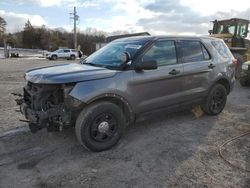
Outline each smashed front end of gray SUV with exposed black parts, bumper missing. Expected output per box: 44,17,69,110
16,82,82,132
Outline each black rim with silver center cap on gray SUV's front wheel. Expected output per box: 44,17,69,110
90,113,118,142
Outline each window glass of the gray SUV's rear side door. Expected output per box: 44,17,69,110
179,40,210,63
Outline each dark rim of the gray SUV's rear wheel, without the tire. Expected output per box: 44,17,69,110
211,90,225,112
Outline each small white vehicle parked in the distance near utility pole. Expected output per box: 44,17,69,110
46,49,78,60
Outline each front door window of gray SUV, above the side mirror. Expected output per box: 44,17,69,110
142,41,177,65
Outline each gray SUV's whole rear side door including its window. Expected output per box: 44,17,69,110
178,40,216,103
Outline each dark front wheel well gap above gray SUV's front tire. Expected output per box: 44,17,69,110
90,97,135,123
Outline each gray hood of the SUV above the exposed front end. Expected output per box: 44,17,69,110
25,63,117,84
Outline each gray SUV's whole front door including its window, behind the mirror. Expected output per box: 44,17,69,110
129,40,183,113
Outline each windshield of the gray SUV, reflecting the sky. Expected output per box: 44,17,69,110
82,40,148,68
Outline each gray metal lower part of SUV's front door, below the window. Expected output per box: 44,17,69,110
129,64,183,113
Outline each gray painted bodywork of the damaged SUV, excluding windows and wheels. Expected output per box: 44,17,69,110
26,37,234,114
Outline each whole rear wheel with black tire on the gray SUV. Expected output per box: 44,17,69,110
202,84,227,115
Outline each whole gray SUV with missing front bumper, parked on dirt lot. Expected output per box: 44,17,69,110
18,36,235,151
